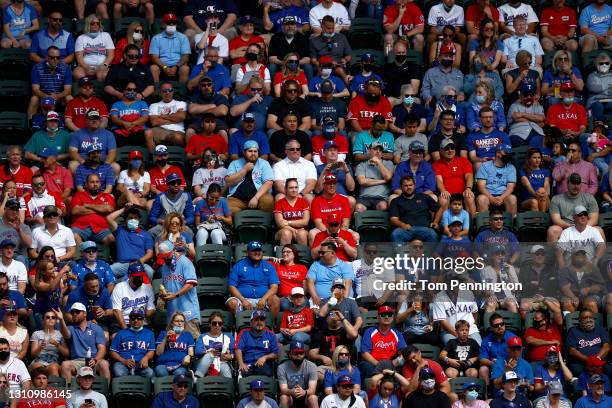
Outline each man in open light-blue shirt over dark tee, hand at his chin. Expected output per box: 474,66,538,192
225,140,274,214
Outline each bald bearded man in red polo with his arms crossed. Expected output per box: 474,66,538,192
70,173,115,245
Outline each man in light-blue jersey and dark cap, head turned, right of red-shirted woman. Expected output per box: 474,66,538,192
476,143,517,217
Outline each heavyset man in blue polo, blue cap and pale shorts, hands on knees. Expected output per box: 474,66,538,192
225,241,280,317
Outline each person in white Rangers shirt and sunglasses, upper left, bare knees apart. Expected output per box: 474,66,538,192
72,14,115,81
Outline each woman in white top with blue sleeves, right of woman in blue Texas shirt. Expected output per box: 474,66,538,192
195,310,235,378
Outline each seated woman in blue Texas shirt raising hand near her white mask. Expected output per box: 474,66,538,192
155,312,195,377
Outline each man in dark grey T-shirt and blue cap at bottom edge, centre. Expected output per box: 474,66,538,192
277,340,319,408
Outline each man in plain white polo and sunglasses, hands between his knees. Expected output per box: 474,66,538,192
273,139,317,204
